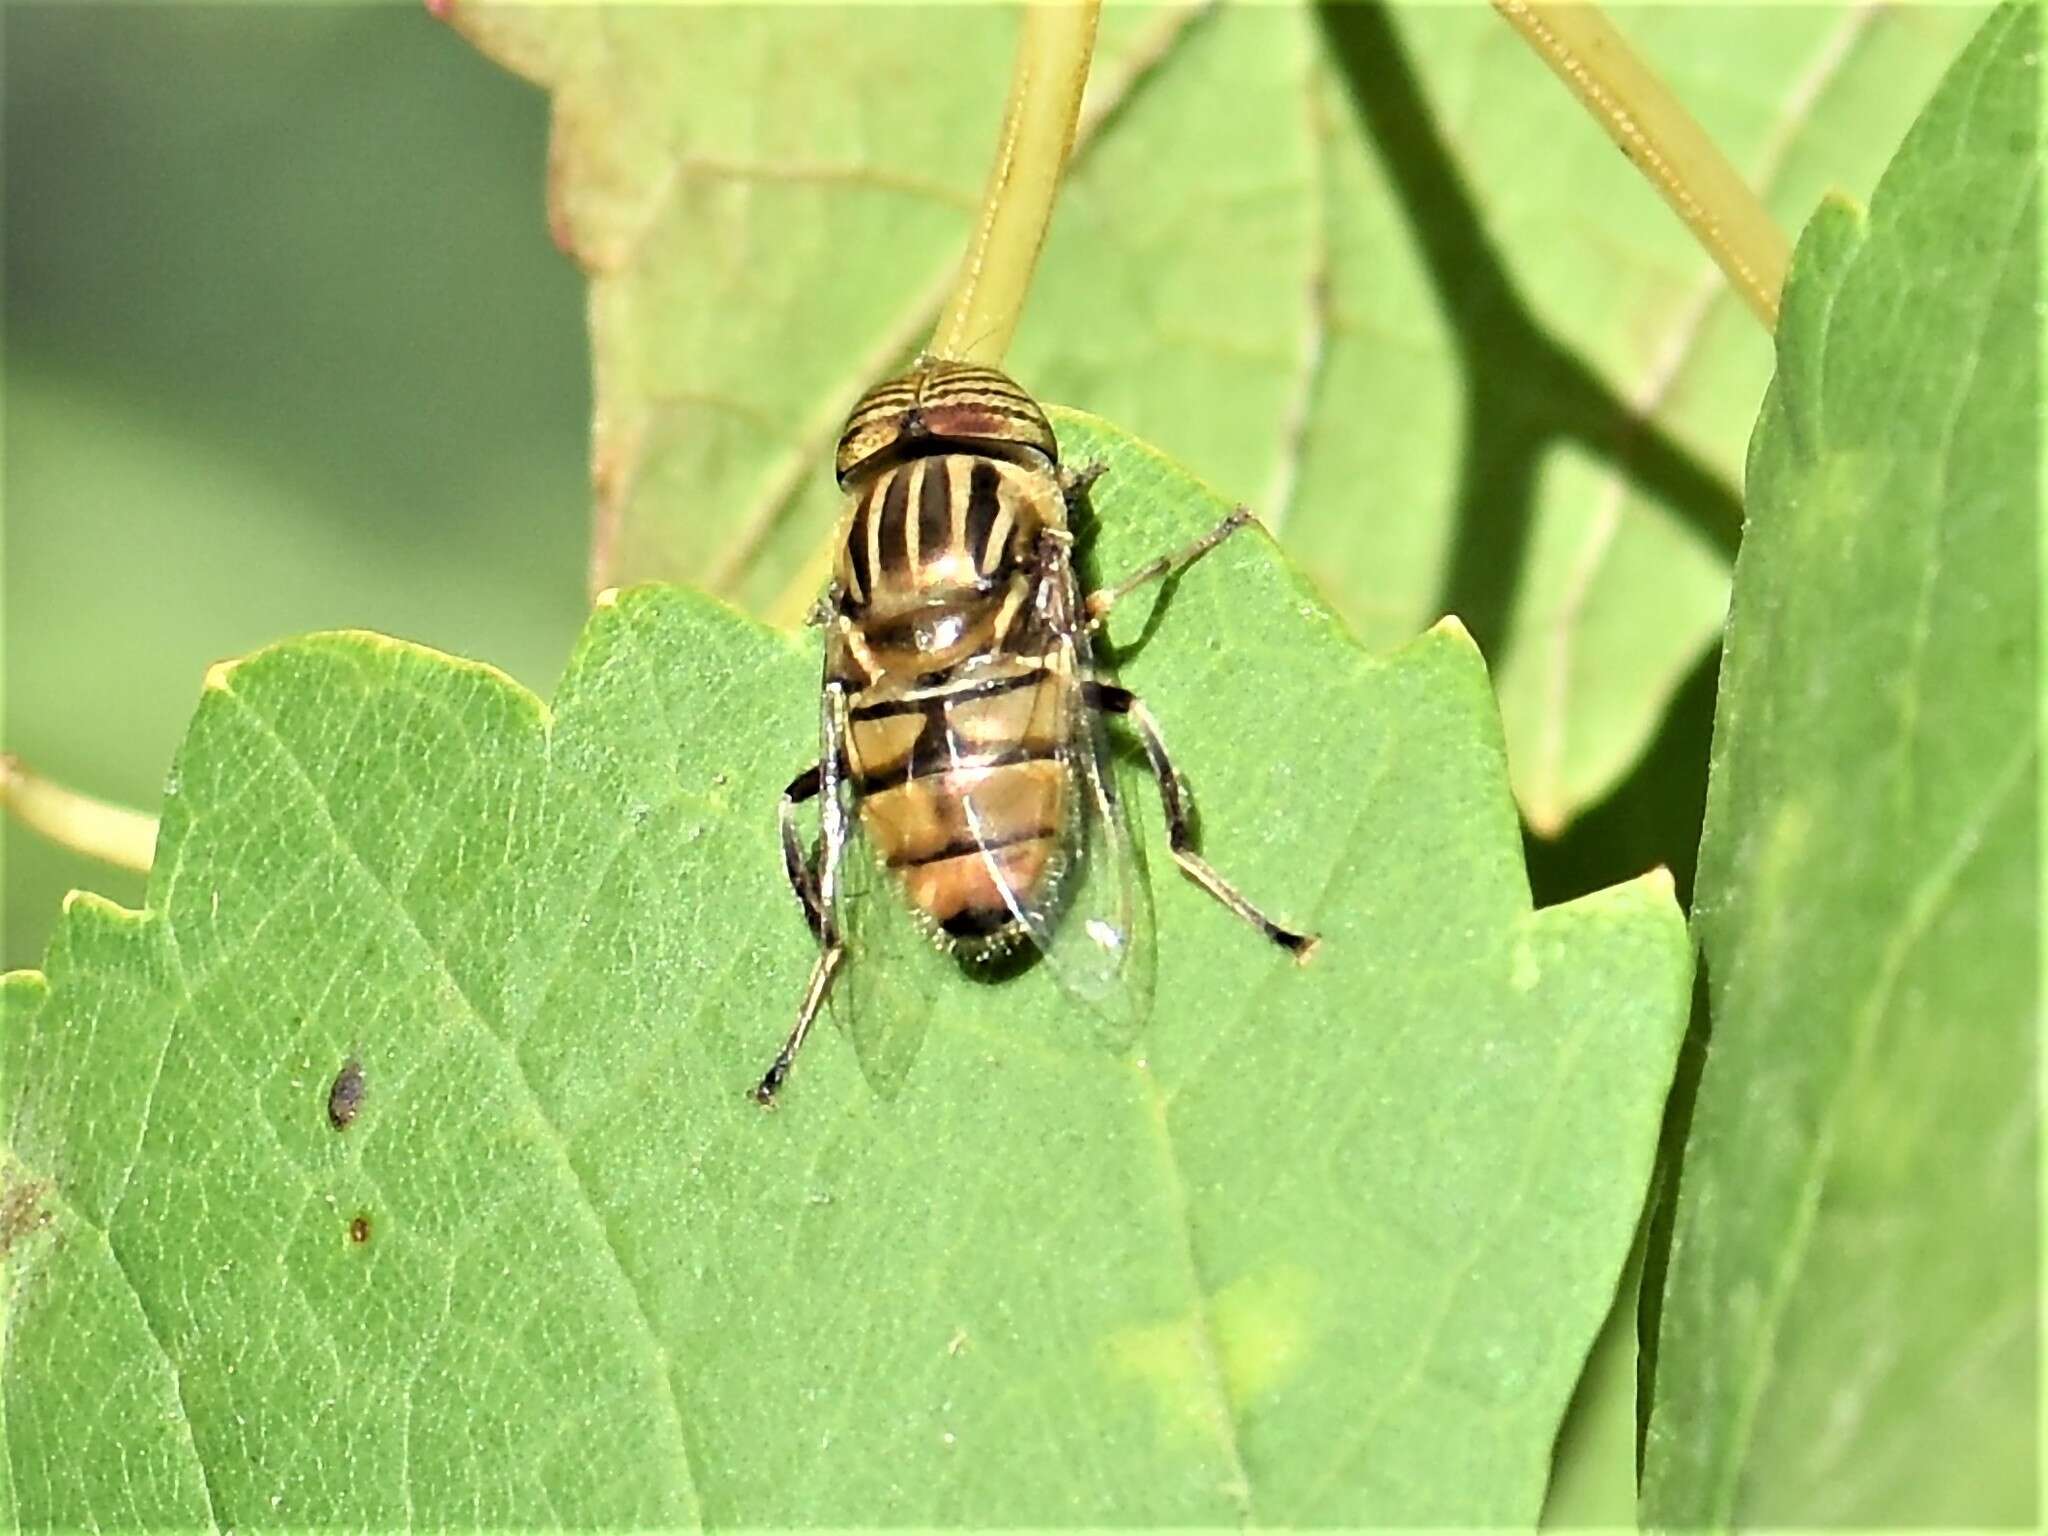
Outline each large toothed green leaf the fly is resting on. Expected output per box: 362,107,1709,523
4,414,1690,1526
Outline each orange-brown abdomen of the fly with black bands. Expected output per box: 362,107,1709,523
846,659,1071,940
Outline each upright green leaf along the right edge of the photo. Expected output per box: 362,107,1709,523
1645,4,2040,1528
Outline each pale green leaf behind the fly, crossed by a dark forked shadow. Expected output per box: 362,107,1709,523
455,0,1980,829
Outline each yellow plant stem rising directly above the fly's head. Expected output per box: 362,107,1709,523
928,0,1102,365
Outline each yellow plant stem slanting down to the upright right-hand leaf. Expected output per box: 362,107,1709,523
1493,0,1792,330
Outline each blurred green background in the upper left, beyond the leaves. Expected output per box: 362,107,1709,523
0,4,590,967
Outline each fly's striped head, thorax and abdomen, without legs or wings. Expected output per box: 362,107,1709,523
831,362,1077,948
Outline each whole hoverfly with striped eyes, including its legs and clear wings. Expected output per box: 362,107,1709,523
754,360,1315,1104
